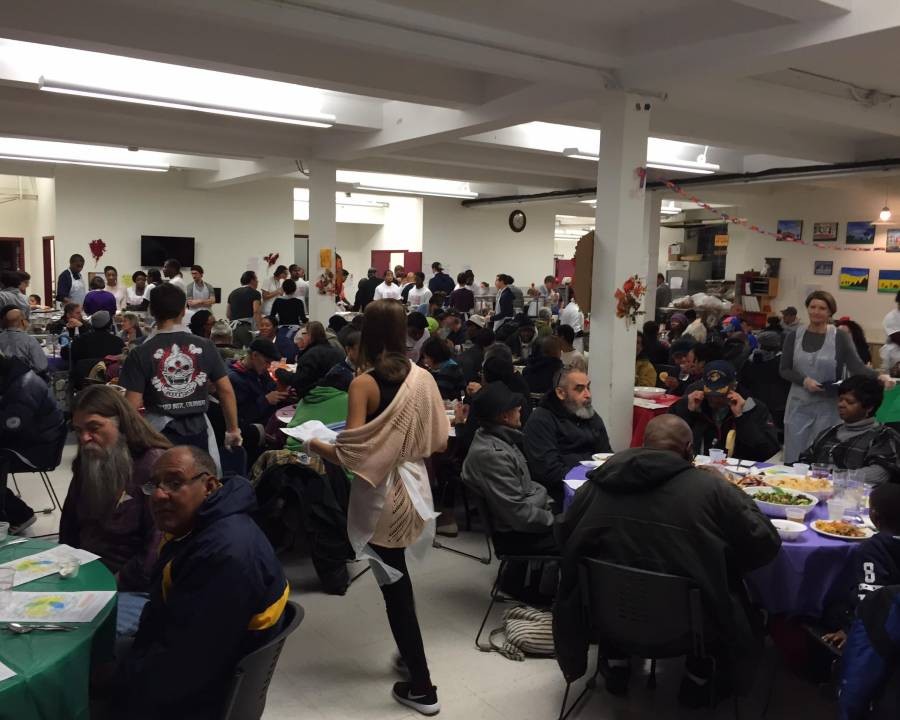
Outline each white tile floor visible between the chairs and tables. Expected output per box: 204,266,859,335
19,444,834,720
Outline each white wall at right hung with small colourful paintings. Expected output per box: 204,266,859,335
724,181,900,342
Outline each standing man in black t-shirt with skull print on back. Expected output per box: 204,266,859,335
119,283,241,466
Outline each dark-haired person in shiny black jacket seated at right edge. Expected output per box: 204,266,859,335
800,375,900,485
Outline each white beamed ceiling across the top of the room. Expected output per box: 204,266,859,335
0,0,900,193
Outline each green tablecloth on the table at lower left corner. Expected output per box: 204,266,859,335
0,540,116,720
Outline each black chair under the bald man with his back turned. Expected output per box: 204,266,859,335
559,558,716,720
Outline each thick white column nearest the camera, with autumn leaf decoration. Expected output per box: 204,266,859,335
590,93,655,451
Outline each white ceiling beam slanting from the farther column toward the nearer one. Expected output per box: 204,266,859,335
316,85,580,161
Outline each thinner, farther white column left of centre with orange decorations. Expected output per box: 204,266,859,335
306,160,337,323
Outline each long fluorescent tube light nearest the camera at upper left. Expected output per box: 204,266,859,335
38,77,336,128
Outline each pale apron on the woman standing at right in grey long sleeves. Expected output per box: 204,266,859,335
784,325,841,464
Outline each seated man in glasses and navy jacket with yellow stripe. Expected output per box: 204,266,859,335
117,446,290,720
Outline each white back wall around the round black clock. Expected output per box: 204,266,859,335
422,198,556,288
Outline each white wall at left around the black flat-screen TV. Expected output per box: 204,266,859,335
56,167,294,317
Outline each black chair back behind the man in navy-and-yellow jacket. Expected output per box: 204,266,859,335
221,601,304,720
